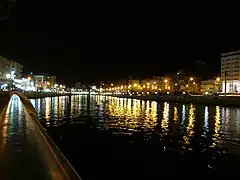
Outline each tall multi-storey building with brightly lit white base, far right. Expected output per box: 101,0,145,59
221,50,240,93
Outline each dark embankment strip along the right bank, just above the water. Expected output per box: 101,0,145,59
110,95,240,106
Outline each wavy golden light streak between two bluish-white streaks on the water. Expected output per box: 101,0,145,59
183,104,195,144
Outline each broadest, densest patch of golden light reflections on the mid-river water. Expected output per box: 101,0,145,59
105,97,157,134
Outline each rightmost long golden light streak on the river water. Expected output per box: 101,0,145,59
211,106,221,147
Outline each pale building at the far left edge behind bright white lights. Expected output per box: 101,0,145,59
0,56,23,79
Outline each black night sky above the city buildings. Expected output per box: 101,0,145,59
0,0,240,84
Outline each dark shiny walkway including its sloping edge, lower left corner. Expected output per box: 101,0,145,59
0,95,80,180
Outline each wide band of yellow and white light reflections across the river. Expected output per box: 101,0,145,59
30,95,240,152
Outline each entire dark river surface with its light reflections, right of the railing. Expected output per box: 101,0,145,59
32,96,240,180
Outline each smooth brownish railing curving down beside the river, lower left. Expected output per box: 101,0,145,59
7,92,81,180
